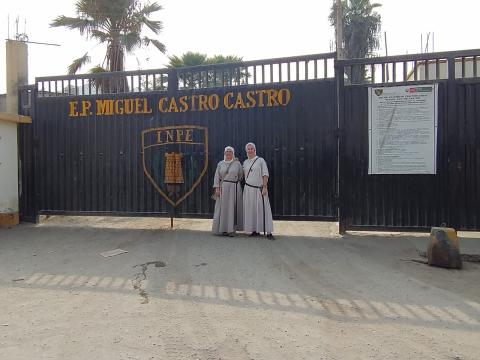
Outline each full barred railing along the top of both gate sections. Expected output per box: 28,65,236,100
36,49,480,97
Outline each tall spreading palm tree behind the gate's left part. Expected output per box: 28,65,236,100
50,0,166,74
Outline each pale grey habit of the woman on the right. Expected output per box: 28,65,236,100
243,156,273,234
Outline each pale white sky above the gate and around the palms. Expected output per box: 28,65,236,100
0,0,480,94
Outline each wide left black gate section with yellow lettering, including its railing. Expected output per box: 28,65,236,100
22,54,338,220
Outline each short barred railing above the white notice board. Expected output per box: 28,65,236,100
339,49,480,85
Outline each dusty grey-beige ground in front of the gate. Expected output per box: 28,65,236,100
0,217,480,360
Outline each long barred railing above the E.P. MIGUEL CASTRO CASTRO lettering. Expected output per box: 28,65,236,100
36,53,335,97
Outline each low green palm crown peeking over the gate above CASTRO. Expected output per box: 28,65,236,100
167,51,247,88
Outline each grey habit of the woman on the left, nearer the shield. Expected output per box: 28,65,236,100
212,159,243,234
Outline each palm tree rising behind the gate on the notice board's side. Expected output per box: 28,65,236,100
328,0,381,83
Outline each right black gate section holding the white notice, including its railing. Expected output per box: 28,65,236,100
337,50,480,231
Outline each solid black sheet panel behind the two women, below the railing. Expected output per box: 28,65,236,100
35,80,337,220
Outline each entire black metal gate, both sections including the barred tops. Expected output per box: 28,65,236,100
20,50,480,232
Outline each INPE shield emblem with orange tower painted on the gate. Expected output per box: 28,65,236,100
142,125,208,207
